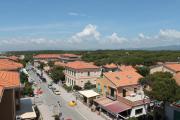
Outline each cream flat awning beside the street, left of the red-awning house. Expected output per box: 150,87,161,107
79,90,99,98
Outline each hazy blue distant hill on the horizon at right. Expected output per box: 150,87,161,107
142,45,180,50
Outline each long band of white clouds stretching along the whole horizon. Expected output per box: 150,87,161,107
0,24,180,50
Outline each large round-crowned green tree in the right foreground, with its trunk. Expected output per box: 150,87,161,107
140,72,180,120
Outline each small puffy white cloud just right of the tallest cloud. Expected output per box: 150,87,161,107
107,33,127,44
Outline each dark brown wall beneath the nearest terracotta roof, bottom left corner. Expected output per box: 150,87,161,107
0,89,15,120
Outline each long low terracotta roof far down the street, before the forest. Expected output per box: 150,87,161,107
33,54,60,59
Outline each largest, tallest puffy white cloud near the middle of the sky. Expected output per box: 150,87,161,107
69,24,100,43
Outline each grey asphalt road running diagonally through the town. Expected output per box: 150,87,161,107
29,66,86,120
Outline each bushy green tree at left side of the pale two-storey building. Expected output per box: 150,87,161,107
50,66,65,83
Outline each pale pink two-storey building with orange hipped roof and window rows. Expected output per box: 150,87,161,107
64,61,101,87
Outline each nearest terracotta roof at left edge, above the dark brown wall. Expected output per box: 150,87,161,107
0,71,20,97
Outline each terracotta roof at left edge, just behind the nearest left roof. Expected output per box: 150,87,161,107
0,59,23,70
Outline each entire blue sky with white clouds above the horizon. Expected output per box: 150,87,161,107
0,0,180,51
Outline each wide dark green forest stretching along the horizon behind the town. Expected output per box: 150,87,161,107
7,50,180,66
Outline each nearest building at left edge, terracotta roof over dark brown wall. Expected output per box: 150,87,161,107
0,71,20,120
